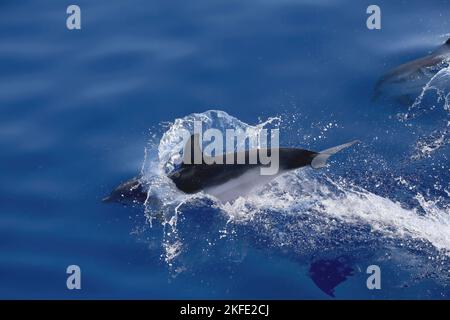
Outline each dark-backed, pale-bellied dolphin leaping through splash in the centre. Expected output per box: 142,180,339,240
103,134,358,203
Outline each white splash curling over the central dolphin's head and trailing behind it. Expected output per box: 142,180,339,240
144,111,450,264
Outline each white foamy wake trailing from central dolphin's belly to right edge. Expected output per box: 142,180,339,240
221,170,450,255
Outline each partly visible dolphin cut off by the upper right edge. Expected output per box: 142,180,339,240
373,39,450,104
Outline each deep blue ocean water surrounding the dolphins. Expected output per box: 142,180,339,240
0,0,450,299
